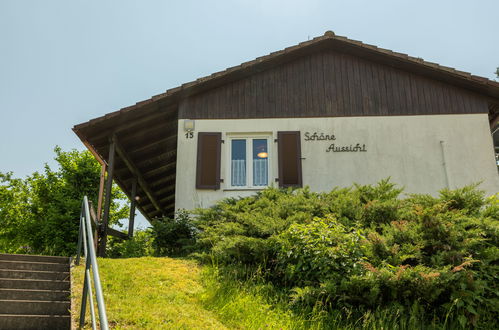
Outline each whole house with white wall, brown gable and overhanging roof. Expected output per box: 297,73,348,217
73,31,499,250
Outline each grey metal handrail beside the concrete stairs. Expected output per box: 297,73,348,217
75,196,109,330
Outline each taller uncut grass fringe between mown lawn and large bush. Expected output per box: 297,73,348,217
201,263,462,330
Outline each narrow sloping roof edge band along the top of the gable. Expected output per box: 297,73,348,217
74,31,499,133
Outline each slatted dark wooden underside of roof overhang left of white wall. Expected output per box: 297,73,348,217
73,101,178,220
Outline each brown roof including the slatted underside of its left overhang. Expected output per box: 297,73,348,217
73,31,499,220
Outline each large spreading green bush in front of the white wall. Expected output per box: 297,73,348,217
191,180,499,327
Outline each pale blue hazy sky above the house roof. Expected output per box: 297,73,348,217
0,0,499,227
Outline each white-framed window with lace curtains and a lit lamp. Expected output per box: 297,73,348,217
229,136,269,188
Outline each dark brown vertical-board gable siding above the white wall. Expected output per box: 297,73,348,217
179,51,488,119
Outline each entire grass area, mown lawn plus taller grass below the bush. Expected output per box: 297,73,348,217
71,257,458,330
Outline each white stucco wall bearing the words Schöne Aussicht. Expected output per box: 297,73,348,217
175,114,499,209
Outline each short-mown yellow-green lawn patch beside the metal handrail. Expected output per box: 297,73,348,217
72,257,226,329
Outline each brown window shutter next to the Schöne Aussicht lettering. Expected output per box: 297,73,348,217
277,131,303,187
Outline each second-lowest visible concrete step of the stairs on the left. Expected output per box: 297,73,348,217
0,300,71,315
